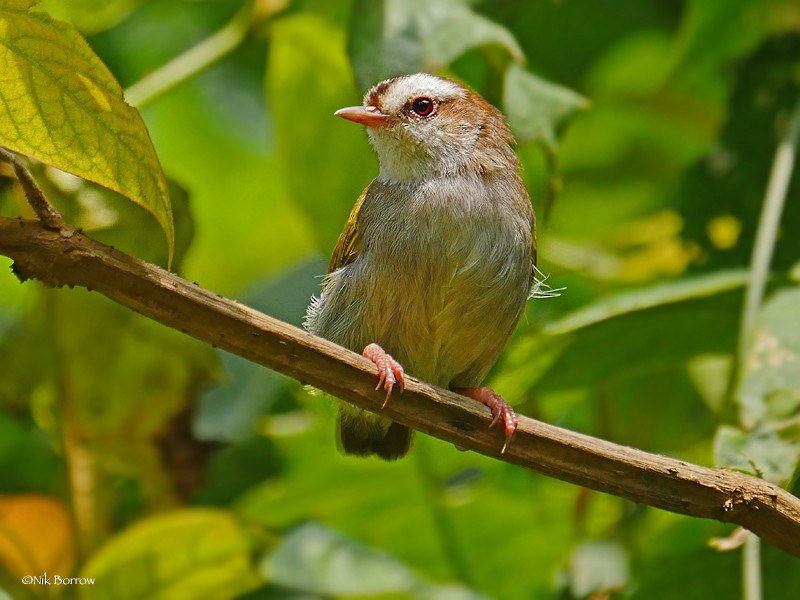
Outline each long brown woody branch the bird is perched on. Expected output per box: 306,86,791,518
0,218,800,556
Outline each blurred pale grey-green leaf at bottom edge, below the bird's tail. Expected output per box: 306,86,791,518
261,523,420,596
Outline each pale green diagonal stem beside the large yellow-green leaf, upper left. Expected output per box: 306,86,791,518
125,0,254,107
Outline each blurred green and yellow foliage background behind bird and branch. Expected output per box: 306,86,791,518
0,0,800,600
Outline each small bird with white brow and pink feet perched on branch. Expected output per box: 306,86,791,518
306,73,536,460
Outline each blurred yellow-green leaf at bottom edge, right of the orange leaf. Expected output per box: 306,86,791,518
81,509,259,600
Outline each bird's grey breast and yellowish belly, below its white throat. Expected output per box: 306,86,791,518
350,176,531,385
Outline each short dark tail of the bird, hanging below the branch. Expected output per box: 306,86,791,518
336,409,414,460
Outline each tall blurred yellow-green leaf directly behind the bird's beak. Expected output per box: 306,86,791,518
266,14,378,253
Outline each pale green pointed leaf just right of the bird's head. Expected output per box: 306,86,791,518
503,63,589,151
